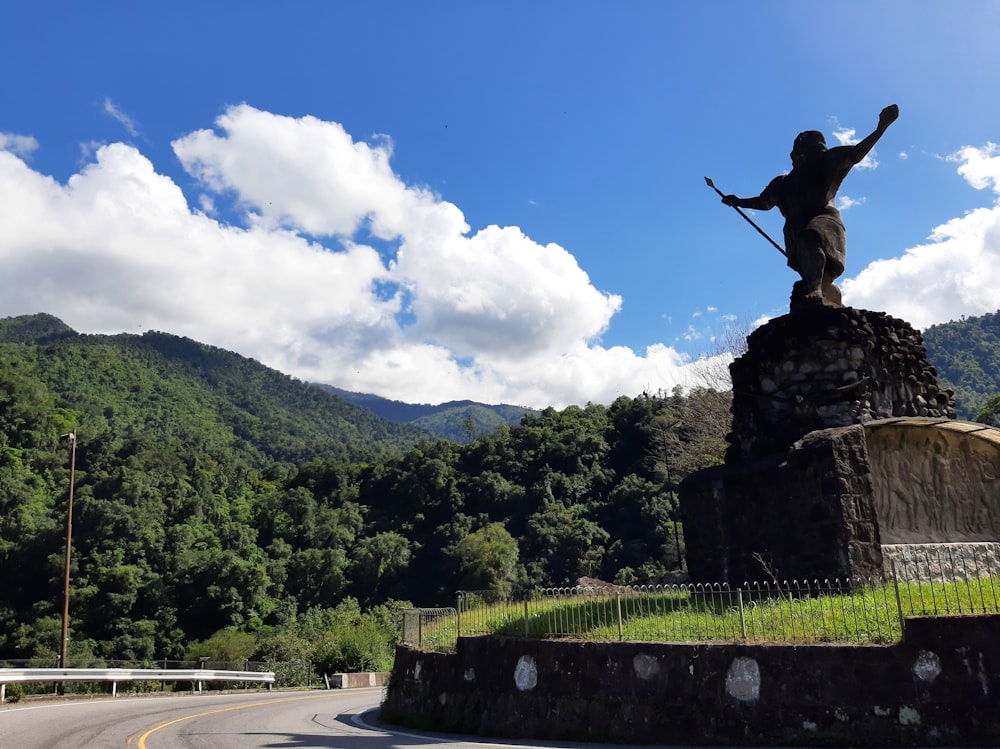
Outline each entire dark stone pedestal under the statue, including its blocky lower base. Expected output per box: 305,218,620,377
680,306,954,585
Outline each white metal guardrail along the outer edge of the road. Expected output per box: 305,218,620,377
0,668,274,703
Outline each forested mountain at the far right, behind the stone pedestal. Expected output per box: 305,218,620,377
923,312,1000,420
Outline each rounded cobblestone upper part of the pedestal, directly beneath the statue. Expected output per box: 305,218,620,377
726,305,955,463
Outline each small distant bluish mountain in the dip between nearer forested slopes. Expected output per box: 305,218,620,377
318,385,538,442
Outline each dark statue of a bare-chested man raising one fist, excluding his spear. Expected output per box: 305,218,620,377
722,104,899,307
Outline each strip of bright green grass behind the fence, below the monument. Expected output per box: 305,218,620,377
408,577,1000,650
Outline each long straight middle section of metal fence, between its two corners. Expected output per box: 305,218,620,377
456,580,902,642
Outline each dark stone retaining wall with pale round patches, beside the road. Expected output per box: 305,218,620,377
382,616,1000,746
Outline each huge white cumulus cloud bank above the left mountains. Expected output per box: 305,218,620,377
0,102,686,406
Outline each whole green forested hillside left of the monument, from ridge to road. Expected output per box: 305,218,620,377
0,316,728,660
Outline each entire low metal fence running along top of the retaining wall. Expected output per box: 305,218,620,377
403,545,1000,649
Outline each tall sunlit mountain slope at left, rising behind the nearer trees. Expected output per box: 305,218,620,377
0,315,428,463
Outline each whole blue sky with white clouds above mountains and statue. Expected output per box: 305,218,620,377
0,0,1000,407
